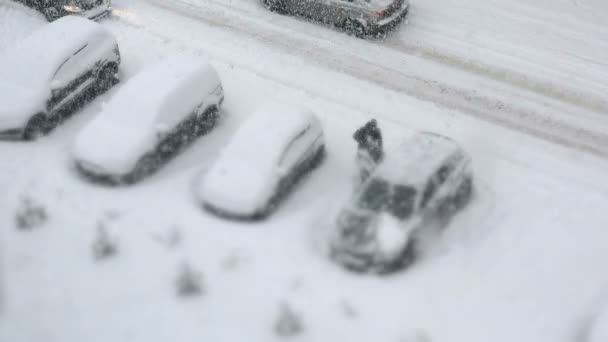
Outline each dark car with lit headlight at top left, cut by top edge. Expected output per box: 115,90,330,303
17,0,112,21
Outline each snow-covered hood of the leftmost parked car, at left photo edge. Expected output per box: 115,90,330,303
0,81,45,130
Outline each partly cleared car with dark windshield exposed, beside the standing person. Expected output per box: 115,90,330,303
330,133,473,273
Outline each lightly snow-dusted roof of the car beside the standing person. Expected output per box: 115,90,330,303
374,132,463,187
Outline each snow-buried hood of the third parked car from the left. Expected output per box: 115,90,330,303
198,156,279,216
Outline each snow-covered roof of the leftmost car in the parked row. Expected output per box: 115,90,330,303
0,16,116,87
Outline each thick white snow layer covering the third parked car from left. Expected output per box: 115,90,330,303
198,103,323,215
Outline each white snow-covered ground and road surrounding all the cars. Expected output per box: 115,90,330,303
0,0,608,342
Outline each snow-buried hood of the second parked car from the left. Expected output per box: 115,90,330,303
73,115,155,176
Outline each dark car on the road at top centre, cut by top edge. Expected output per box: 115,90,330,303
262,0,410,37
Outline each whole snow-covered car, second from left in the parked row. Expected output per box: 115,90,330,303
73,56,224,184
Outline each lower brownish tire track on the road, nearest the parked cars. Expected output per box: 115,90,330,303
142,0,608,158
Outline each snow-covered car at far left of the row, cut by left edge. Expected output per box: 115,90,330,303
0,17,120,140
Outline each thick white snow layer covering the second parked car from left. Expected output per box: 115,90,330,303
73,55,221,175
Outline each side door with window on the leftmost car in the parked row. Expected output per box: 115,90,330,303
47,43,95,112
